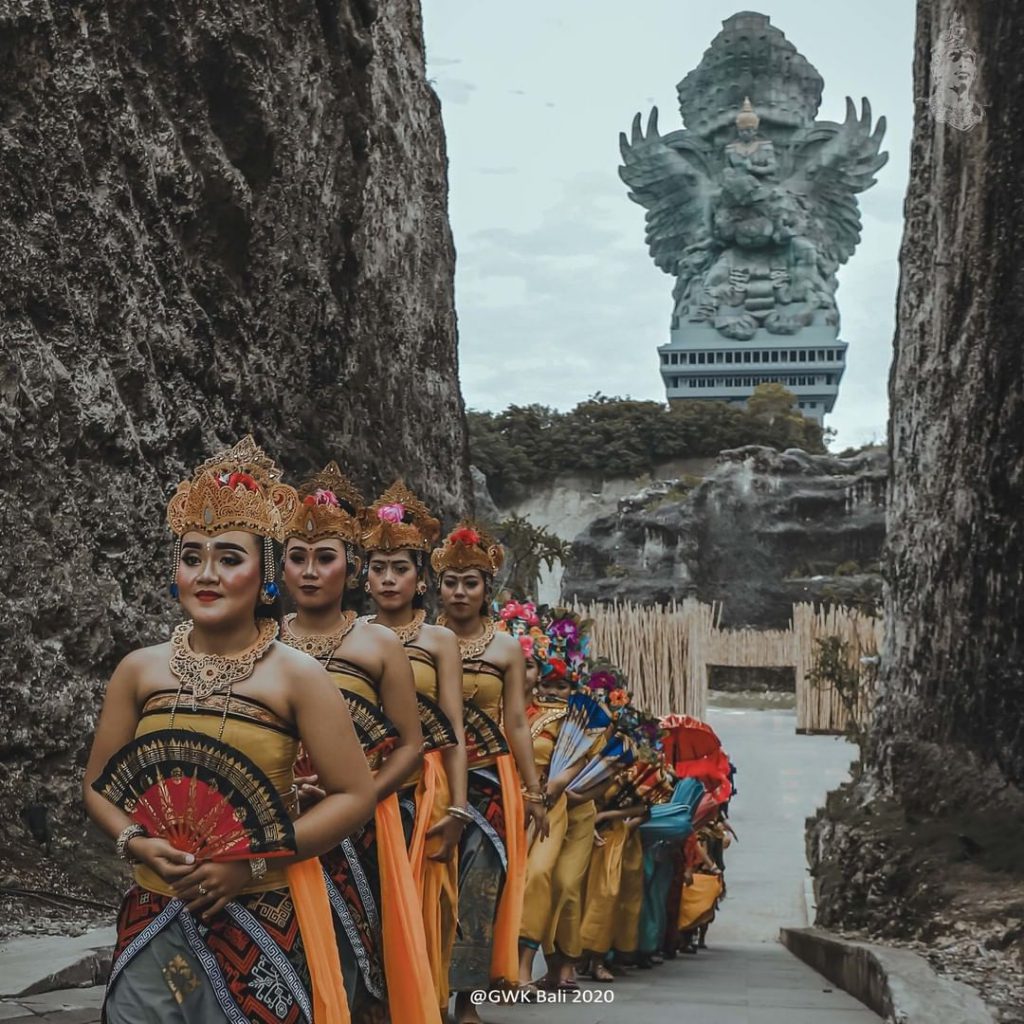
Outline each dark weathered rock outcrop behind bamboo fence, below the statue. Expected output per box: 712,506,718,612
562,446,887,628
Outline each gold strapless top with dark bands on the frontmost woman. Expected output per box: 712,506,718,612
135,690,299,896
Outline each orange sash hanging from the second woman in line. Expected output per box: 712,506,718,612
376,793,440,1024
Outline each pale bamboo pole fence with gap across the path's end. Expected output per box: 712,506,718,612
577,598,882,733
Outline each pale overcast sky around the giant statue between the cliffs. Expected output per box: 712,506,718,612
423,0,914,449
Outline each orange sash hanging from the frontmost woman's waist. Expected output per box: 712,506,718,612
285,857,351,1024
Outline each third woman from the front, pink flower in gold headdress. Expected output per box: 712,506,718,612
362,481,471,1010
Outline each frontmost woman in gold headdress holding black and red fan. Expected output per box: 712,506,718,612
84,437,374,1024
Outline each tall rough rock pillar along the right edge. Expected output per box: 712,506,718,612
811,0,1024,1007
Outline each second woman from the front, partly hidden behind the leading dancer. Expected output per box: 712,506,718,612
283,463,438,1024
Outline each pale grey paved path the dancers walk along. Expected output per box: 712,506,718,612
0,709,880,1024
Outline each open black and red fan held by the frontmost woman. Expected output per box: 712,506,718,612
92,729,295,861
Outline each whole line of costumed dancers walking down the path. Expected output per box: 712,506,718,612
83,437,733,1024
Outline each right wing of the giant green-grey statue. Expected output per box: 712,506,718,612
785,96,889,264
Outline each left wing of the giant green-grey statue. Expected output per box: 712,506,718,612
618,106,714,274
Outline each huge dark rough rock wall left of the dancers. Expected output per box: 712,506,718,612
0,0,472,888
